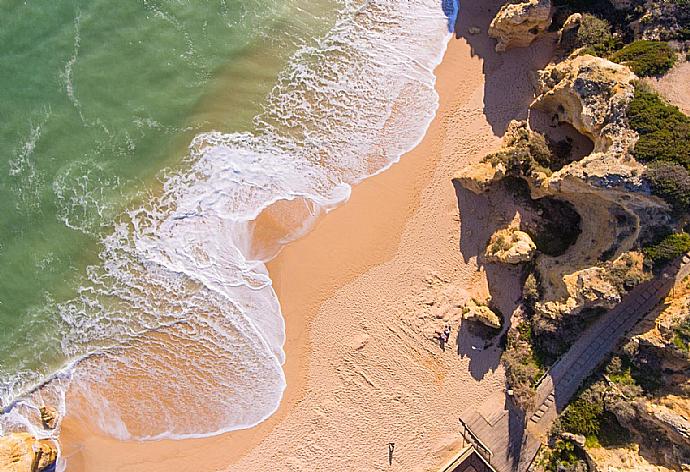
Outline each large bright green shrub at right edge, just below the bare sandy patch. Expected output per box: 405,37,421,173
628,83,690,170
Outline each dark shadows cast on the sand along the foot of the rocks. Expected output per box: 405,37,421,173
446,0,555,464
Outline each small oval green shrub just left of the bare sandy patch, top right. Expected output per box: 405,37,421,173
609,39,676,77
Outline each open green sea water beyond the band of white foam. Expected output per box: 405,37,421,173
0,0,334,399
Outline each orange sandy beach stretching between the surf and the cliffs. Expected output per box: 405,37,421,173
62,0,549,472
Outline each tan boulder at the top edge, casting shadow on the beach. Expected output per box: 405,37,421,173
489,0,552,52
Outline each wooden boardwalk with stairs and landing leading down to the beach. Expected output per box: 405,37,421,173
460,256,690,472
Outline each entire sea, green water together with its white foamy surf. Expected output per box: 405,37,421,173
0,0,454,439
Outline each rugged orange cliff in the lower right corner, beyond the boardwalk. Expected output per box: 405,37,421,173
576,281,690,471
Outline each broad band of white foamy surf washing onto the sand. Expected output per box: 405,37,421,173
0,0,448,439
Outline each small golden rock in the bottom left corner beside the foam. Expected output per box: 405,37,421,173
0,433,58,472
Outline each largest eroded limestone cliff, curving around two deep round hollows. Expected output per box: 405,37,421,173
456,55,670,328
